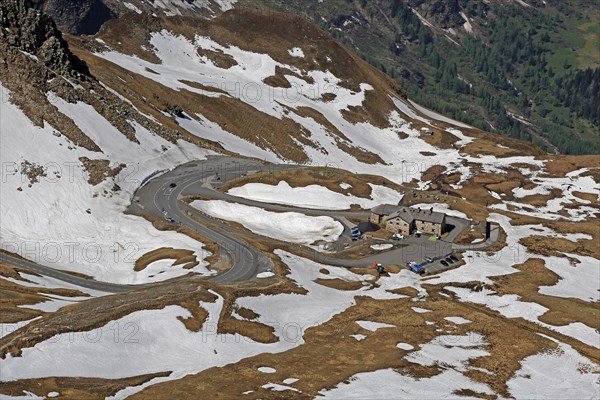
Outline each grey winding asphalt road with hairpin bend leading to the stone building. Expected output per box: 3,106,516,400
0,156,495,293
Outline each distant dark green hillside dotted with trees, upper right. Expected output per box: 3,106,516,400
241,0,600,154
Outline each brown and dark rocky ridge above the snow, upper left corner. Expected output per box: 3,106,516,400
0,0,190,152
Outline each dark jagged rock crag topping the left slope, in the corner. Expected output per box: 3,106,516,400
0,0,89,79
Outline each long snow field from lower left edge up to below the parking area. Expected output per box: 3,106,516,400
0,251,404,398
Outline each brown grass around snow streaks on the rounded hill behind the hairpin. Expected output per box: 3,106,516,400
68,9,412,163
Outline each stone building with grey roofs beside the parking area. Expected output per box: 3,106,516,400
370,204,446,236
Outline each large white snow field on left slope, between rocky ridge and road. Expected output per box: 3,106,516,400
0,87,216,283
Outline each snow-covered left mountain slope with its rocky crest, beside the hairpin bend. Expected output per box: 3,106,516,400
0,1,216,282
